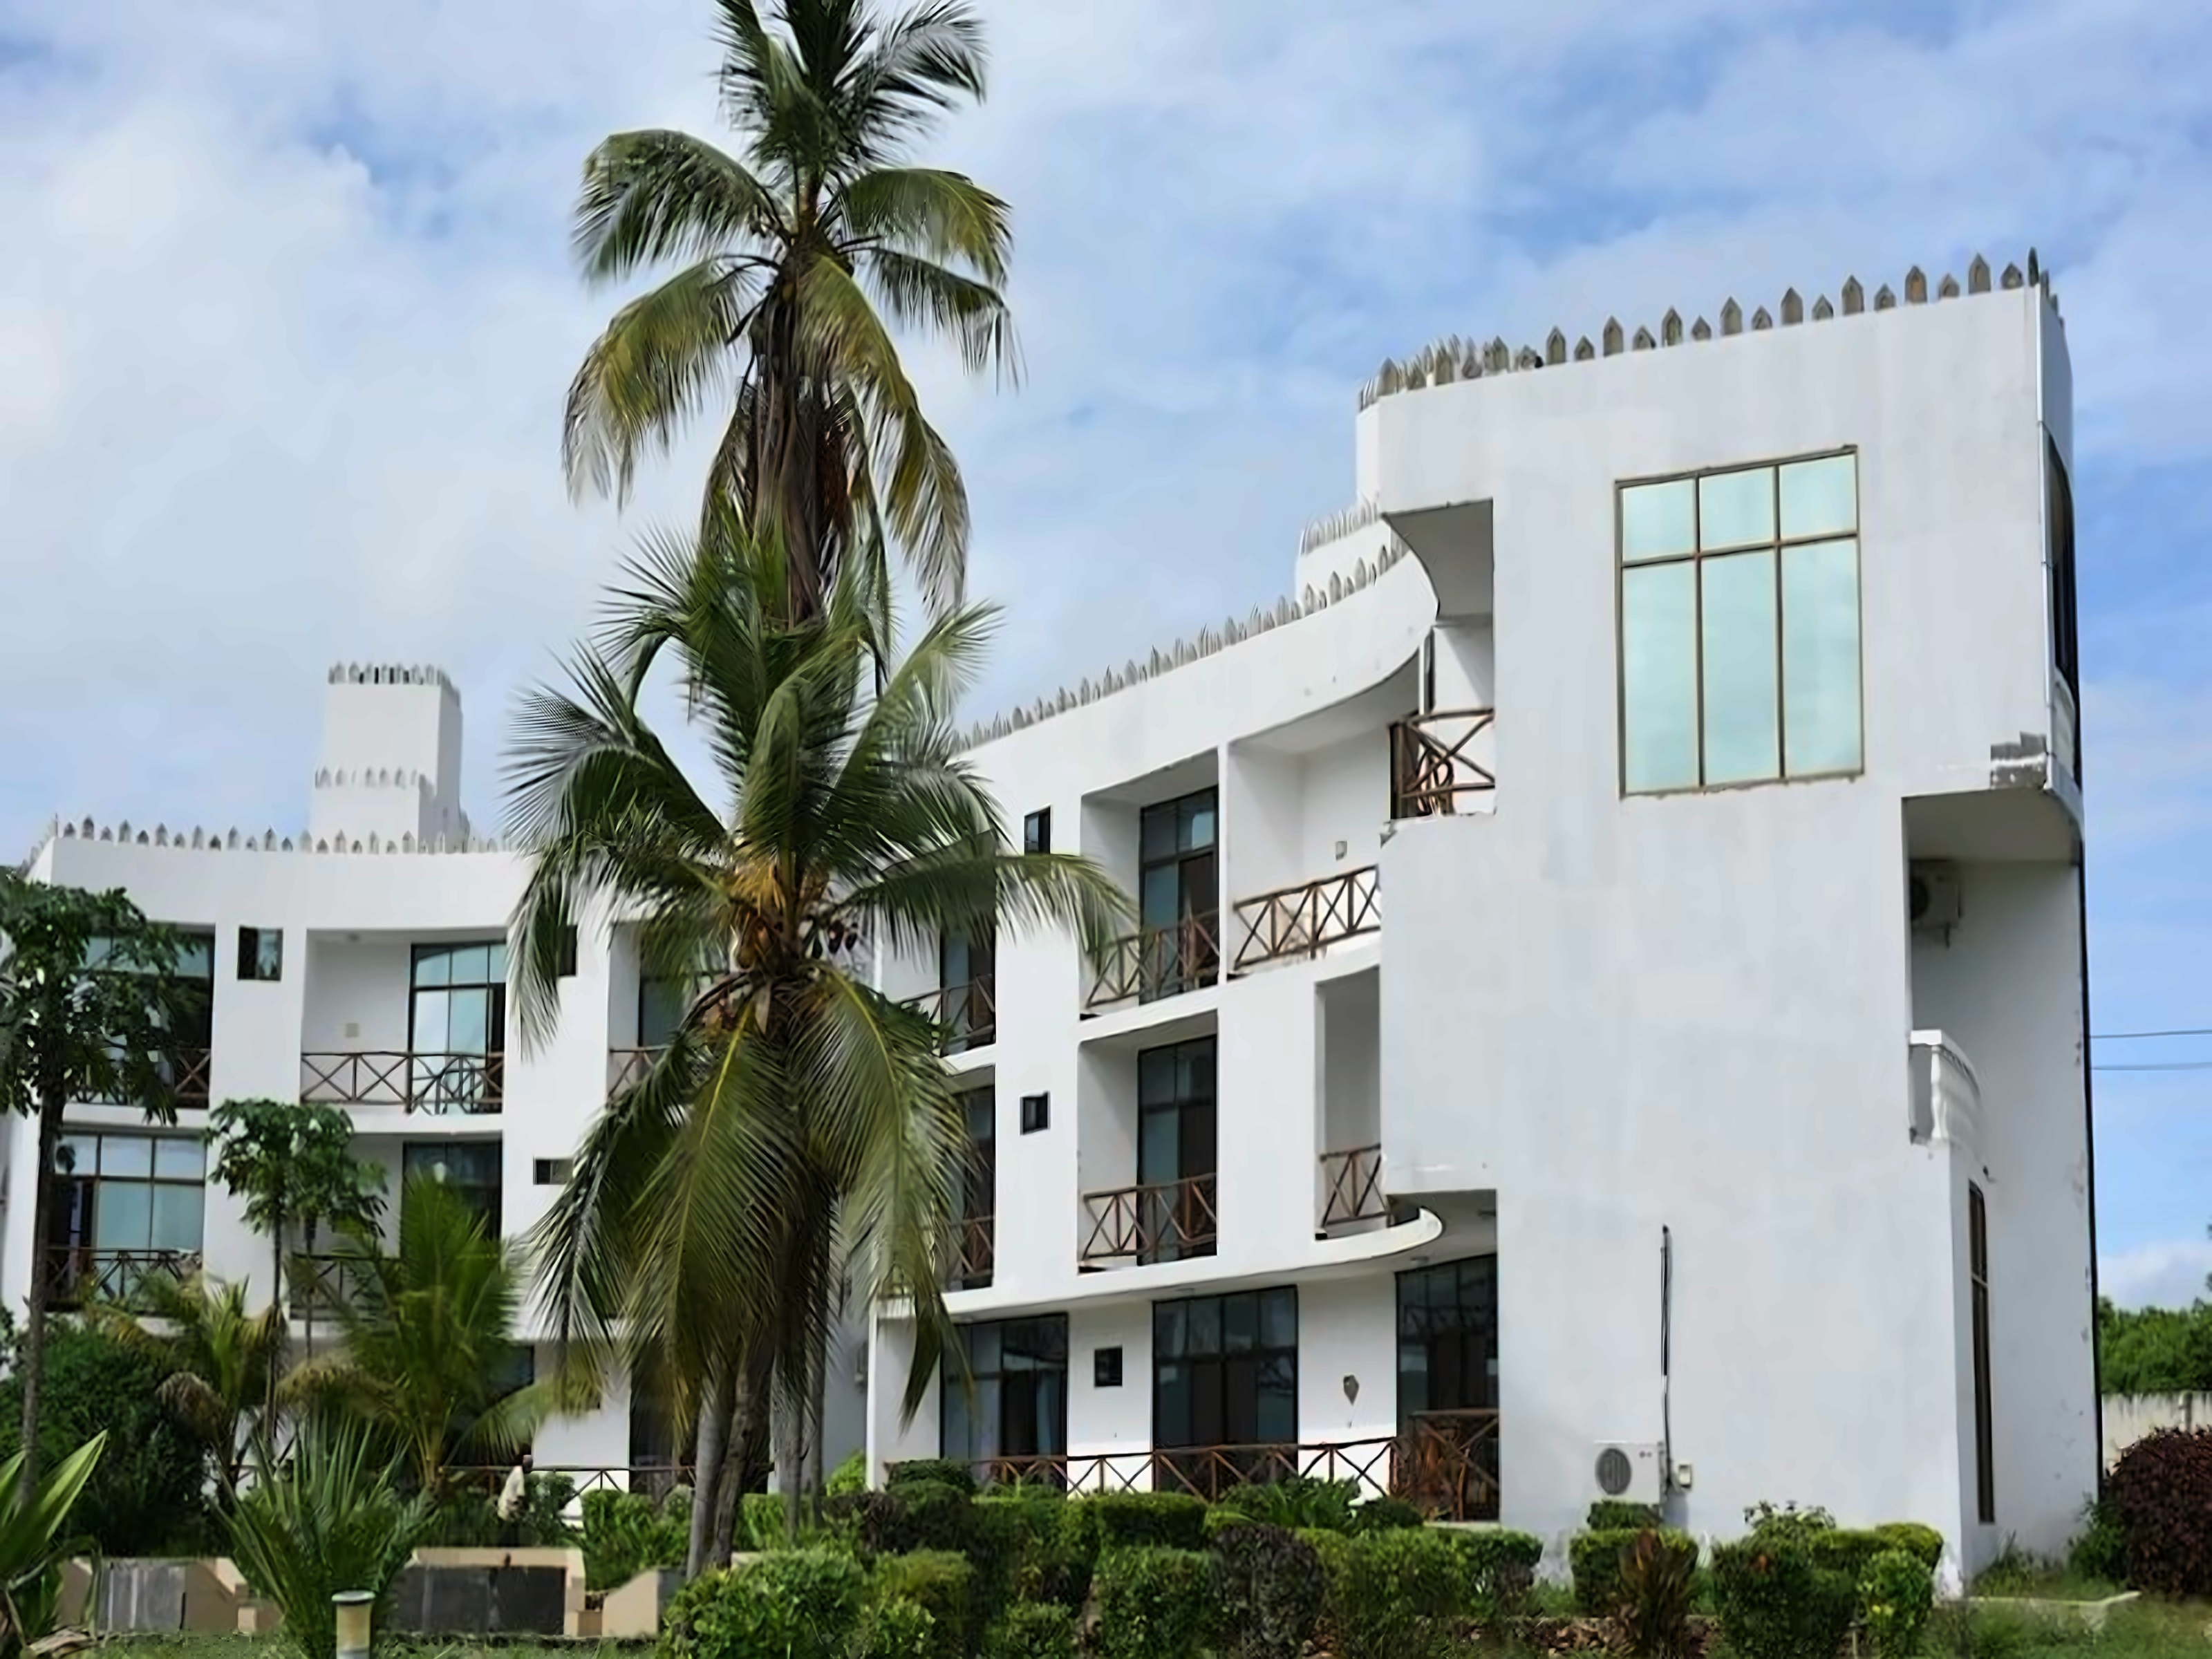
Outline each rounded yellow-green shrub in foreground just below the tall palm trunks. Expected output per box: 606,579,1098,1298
659,1548,867,1659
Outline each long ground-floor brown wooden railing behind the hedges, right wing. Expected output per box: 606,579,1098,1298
898,1412,1497,1519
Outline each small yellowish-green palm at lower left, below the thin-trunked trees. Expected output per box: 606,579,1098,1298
84,1274,285,1493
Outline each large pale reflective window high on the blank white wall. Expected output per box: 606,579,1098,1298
1619,453,1865,794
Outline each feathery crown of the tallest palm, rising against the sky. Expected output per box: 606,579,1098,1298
562,0,1018,626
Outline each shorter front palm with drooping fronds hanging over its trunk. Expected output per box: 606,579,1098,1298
511,520,1128,1566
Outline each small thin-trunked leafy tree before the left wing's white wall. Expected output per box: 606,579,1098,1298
208,1099,385,1353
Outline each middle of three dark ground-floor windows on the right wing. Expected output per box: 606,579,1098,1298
1152,1285,1298,1449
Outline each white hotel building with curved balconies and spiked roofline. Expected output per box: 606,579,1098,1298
4,259,2097,1568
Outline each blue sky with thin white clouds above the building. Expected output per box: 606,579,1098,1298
0,0,2212,1301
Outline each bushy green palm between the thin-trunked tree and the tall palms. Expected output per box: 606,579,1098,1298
283,1179,577,1495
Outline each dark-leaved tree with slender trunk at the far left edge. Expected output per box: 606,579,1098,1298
0,870,206,1502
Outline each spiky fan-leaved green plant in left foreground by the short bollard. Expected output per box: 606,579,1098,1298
230,1420,433,1659
